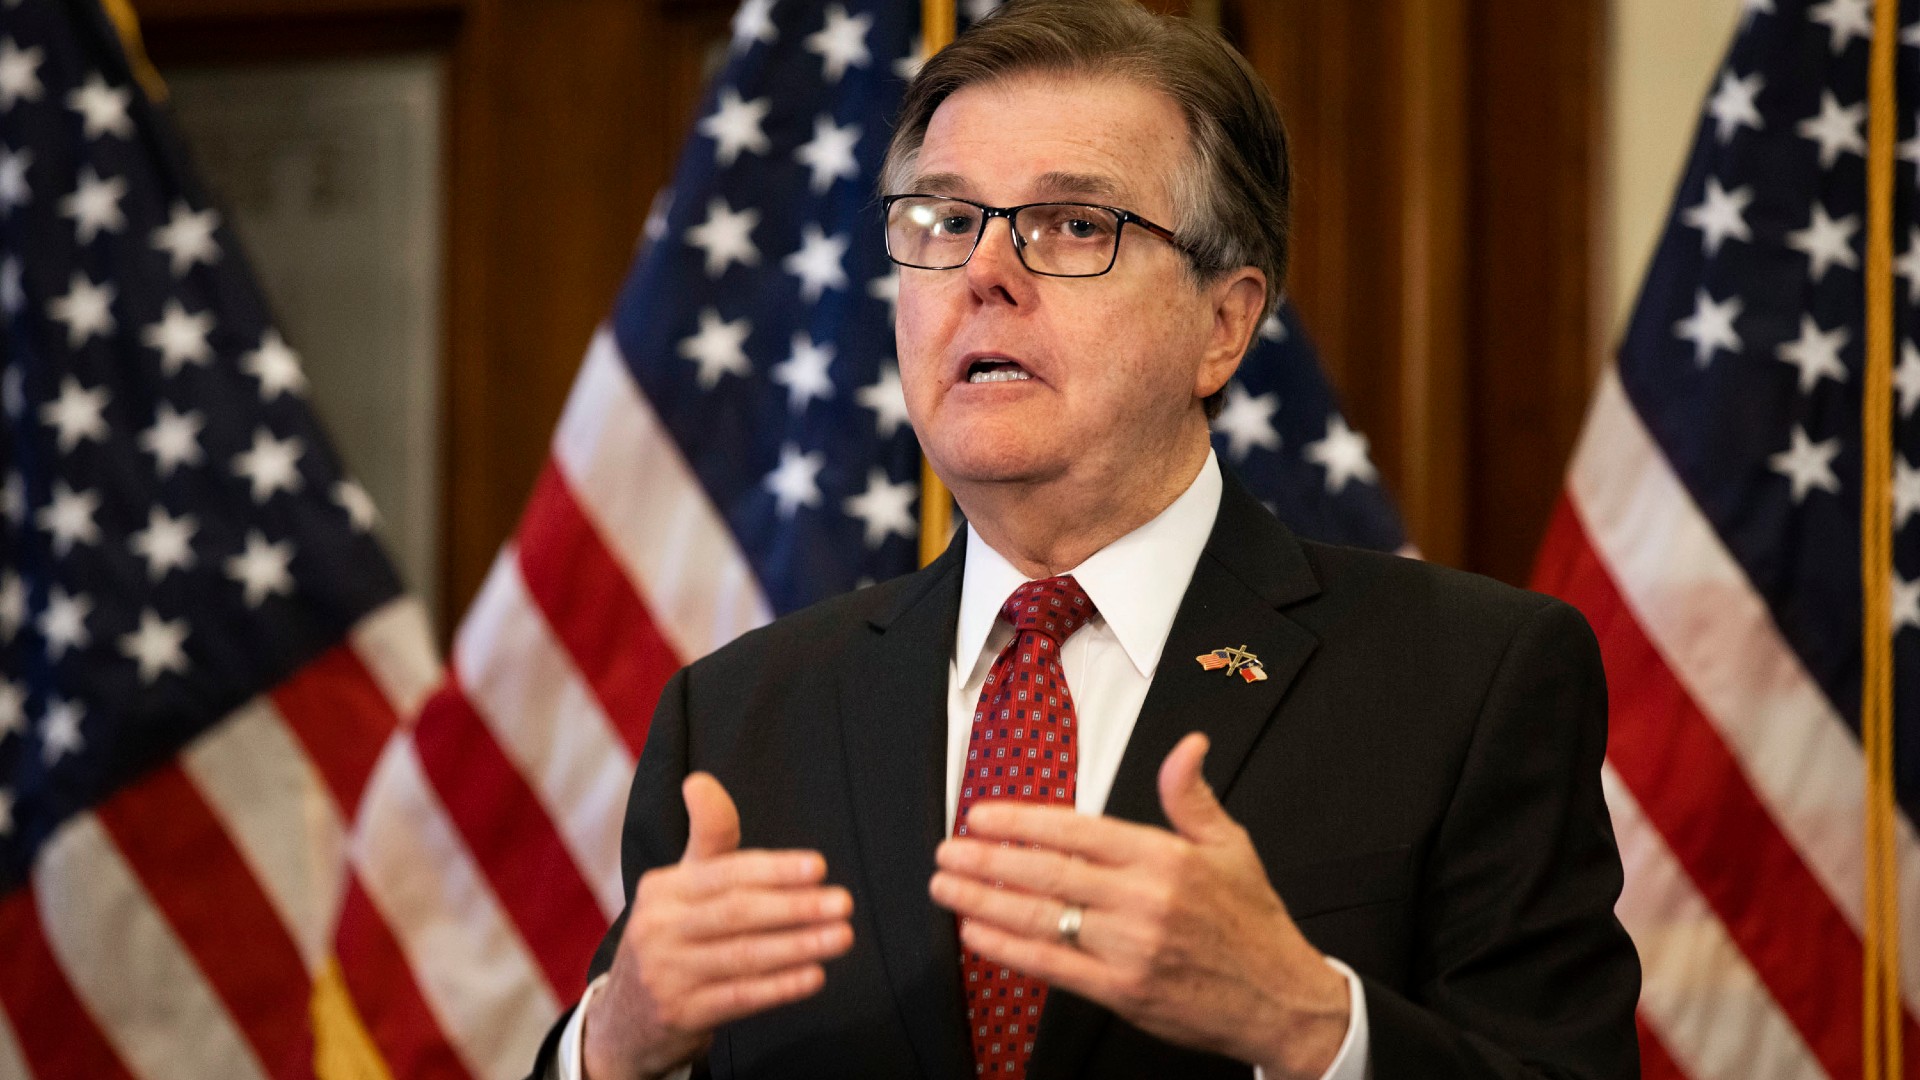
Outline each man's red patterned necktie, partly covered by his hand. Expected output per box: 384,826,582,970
954,577,1094,1080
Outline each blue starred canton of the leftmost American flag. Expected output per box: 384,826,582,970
0,0,399,892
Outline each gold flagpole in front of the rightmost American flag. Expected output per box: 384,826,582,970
1860,0,1905,1080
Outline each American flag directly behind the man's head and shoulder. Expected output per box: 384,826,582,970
322,0,1404,1080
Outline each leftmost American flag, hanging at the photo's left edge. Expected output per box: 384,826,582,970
0,0,438,1078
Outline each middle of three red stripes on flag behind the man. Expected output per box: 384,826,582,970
413,675,607,1001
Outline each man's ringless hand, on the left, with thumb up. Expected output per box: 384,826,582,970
584,773,852,1080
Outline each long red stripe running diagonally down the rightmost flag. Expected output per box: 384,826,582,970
1534,500,1920,1076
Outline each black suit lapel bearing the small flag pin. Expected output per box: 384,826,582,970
1027,467,1317,1080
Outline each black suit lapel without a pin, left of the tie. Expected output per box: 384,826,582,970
839,530,973,1078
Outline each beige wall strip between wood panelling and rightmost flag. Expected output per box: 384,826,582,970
1601,0,1741,336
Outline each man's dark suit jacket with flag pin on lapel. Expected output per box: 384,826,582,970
541,466,1640,1080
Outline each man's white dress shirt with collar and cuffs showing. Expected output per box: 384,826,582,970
557,452,1371,1080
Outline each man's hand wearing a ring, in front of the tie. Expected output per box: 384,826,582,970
929,732,1350,1080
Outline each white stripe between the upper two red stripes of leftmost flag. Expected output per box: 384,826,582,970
180,698,346,972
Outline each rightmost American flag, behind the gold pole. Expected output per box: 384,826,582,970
1536,0,1920,1080
